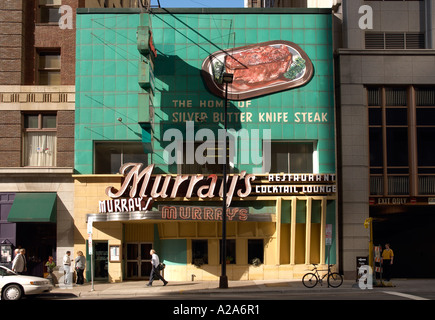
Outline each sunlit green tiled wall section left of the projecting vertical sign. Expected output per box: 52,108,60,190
75,14,141,173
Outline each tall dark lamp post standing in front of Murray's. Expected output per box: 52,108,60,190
219,72,233,289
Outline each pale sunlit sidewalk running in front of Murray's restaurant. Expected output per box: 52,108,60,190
51,279,428,299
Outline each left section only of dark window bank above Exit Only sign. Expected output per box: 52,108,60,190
367,87,409,195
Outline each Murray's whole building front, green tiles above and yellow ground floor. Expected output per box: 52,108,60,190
75,9,338,281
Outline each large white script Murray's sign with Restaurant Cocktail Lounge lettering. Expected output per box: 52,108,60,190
99,163,337,213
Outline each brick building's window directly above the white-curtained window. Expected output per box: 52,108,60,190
37,50,61,85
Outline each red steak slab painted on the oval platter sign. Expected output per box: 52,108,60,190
225,45,292,84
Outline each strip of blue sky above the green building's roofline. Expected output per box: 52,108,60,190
151,0,244,8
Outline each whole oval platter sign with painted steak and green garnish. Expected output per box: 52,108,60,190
201,40,314,100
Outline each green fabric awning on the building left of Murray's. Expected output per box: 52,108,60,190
8,192,57,223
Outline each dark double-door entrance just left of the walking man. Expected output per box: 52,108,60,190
126,242,153,280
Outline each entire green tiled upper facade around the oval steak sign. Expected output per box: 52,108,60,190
75,9,335,174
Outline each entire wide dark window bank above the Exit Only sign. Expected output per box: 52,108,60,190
367,86,435,196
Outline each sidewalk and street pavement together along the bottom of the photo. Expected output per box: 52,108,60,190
46,279,435,300
